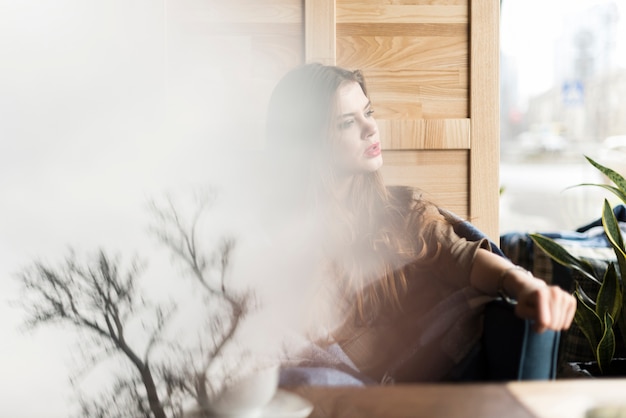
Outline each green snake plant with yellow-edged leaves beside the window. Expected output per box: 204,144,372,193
530,157,626,375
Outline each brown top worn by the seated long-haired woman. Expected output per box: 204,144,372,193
332,202,493,382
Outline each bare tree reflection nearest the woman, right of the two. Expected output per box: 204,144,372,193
151,196,252,406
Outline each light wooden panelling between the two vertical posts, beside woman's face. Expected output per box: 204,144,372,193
336,0,471,229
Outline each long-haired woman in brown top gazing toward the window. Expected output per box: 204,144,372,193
260,64,576,381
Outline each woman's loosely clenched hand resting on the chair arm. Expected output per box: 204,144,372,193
515,279,576,332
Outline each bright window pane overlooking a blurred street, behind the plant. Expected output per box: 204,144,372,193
500,0,626,233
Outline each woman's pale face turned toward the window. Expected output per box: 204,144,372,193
333,82,383,176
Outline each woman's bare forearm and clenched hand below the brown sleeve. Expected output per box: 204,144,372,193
470,248,576,332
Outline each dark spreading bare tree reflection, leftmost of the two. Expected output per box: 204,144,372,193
19,251,172,418
